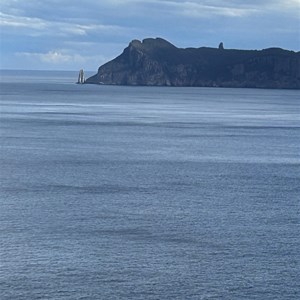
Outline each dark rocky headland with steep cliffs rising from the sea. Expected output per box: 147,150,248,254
86,38,300,89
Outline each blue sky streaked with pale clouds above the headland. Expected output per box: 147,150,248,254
0,0,300,71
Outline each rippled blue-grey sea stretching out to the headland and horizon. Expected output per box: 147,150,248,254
0,71,300,300
